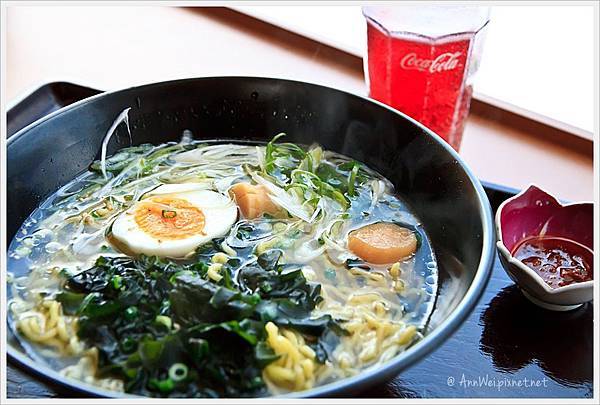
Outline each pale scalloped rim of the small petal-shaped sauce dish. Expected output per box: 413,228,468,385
495,183,594,299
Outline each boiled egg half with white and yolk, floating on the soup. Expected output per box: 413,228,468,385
111,183,237,258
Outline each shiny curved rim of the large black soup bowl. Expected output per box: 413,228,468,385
6,75,495,398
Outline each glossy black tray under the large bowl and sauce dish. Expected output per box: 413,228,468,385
6,82,593,398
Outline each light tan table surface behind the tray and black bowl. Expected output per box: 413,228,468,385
6,6,593,200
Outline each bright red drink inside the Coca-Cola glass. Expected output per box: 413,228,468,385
365,7,487,150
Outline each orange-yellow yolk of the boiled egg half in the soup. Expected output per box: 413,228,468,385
134,197,205,240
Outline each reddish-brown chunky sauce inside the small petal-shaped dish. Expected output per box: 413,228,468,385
512,237,594,288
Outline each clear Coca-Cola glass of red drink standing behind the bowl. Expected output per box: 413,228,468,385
363,5,489,150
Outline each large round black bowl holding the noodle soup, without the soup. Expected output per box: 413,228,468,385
6,77,494,396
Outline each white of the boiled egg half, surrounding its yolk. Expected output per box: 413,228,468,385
112,183,237,258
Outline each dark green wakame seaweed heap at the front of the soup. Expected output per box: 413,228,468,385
57,245,345,397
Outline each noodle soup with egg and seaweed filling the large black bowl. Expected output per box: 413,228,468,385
9,136,438,397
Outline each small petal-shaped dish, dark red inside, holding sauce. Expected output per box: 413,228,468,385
496,185,595,311
